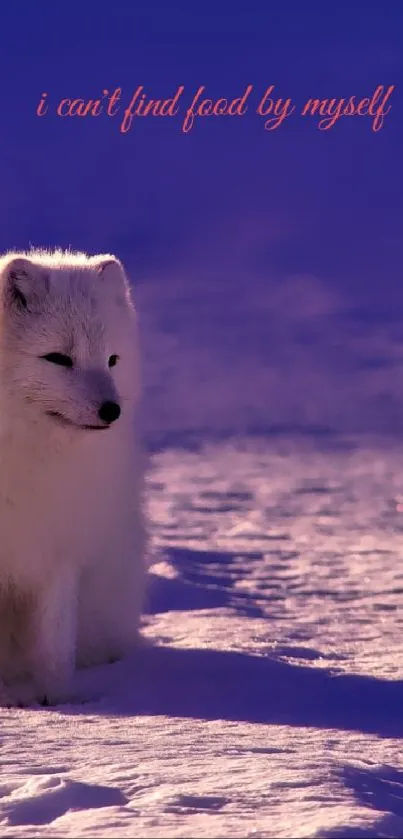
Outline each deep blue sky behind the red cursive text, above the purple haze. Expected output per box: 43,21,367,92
0,0,403,308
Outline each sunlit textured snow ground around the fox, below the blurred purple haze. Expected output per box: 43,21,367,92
0,434,403,837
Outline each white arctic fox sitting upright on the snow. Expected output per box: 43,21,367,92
0,250,146,705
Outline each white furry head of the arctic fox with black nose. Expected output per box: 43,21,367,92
0,251,139,434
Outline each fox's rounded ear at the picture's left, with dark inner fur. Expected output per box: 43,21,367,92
3,257,49,311
